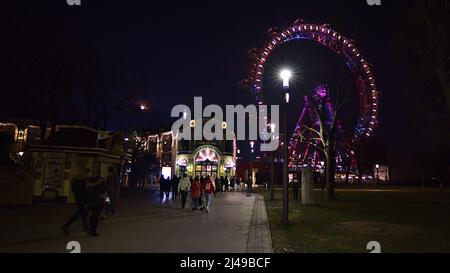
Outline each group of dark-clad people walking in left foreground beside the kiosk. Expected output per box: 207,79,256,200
61,167,120,237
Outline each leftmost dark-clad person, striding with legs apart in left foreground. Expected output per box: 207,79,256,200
61,169,91,235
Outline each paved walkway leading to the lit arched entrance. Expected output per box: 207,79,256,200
0,192,272,253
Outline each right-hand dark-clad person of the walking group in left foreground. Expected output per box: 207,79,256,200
86,171,107,237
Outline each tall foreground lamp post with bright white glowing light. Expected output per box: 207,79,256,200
280,70,292,225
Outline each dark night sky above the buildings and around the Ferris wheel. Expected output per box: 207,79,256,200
0,0,442,160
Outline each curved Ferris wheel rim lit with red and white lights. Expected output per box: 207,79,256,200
248,20,380,142
